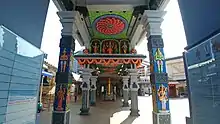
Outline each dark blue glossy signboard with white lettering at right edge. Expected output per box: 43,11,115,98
186,34,220,124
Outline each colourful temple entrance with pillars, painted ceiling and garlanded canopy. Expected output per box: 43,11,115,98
53,1,170,124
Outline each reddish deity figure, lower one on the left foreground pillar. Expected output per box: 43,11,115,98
57,85,66,111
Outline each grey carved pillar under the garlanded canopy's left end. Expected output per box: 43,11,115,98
80,68,91,115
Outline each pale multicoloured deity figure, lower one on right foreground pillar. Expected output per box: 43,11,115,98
157,84,168,111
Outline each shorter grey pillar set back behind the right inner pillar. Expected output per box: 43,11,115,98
122,76,129,107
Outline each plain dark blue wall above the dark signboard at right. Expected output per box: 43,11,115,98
178,0,220,45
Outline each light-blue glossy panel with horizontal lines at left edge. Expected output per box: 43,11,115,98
0,27,44,124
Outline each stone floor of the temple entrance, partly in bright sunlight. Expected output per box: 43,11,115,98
40,96,189,124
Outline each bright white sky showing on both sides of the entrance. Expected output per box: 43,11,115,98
41,0,186,67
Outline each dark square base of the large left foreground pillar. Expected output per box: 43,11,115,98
51,110,70,124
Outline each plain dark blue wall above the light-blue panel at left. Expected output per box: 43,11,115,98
0,0,49,48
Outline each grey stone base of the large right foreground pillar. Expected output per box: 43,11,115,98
152,112,171,124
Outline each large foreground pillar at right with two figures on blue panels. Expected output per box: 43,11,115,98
144,10,171,124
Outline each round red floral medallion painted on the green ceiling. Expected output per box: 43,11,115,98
96,17,125,35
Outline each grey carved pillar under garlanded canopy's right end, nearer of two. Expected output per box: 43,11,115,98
129,69,140,116
